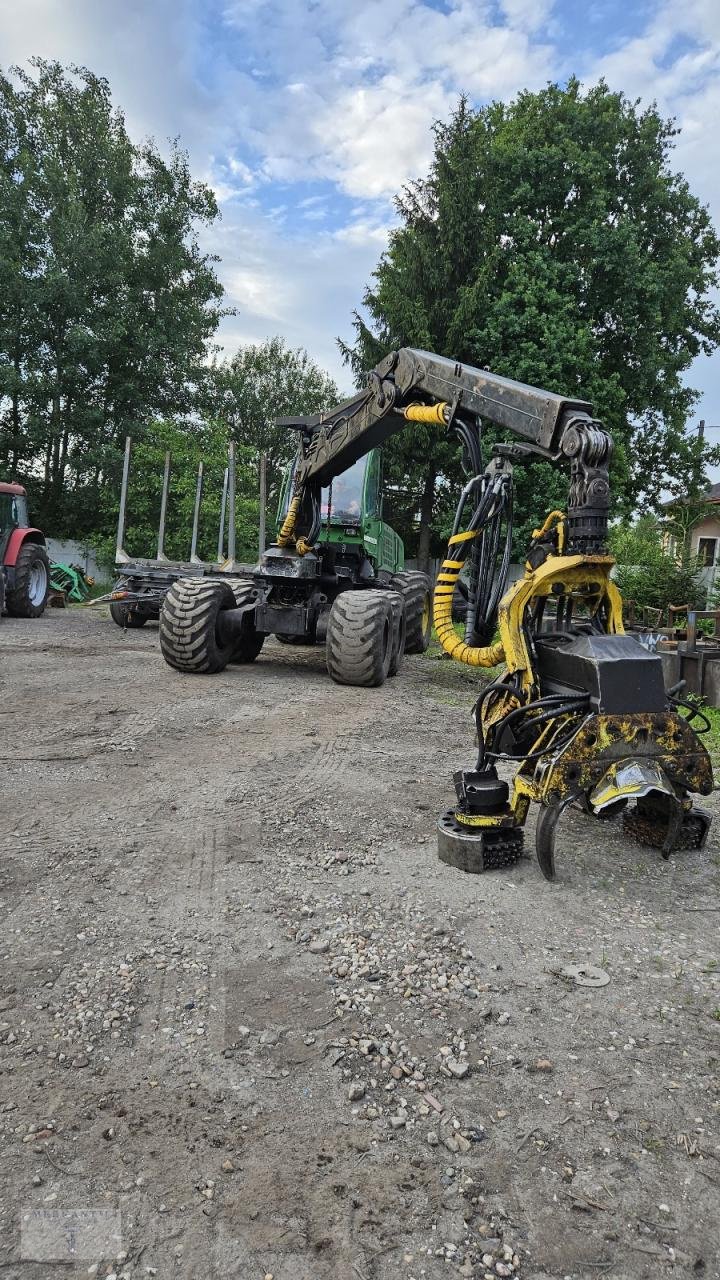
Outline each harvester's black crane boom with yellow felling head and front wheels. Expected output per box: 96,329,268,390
160,348,712,879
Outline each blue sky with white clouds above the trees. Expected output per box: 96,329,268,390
0,0,720,422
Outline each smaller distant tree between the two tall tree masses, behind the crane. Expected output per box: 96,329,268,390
214,337,340,524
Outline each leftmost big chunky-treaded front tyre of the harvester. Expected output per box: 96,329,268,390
160,577,237,676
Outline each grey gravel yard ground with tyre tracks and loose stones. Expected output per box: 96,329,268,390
0,609,720,1280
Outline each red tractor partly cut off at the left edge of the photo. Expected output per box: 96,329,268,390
0,481,50,618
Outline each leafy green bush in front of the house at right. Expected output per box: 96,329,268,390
610,516,705,613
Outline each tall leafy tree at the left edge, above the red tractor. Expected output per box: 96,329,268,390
0,59,222,535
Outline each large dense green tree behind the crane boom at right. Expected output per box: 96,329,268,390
342,79,720,570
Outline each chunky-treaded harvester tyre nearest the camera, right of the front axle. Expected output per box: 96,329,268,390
325,590,395,689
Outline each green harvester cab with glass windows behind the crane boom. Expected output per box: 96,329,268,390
278,449,405,576
